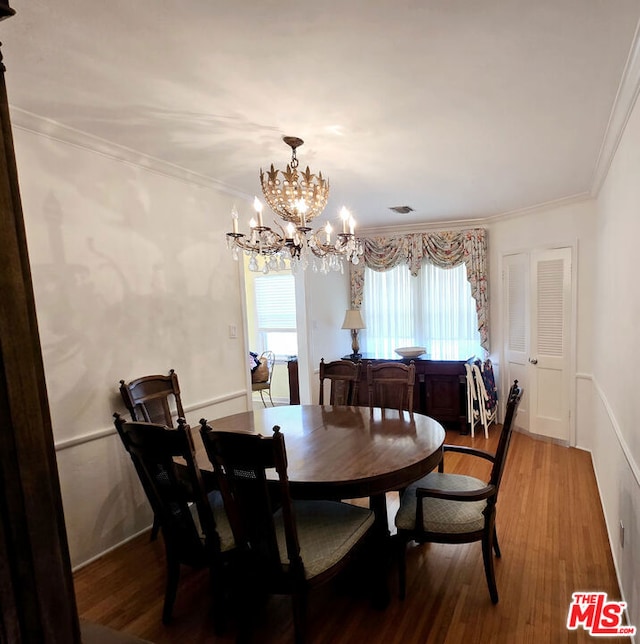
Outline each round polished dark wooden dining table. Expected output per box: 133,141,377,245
196,405,445,526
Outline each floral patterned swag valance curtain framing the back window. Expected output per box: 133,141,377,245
351,228,489,352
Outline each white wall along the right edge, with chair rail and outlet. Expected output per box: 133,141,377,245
585,88,640,626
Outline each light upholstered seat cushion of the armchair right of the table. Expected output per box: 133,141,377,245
395,472,487,534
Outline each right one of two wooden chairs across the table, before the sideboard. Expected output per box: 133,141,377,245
367,360,416,413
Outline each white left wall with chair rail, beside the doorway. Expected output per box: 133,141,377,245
14,123,247,566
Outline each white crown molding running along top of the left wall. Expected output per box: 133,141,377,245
10,105,253,200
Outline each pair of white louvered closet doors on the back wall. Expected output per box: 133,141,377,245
503,248,573,441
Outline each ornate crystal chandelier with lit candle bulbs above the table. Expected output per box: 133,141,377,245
227,136,363,273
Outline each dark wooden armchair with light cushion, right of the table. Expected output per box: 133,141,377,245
395,380,522,604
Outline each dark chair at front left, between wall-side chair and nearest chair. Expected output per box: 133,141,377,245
113,413,235,632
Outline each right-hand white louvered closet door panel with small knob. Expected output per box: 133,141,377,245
529,248,572,441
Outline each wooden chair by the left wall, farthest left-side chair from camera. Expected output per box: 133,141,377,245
120,369,185,427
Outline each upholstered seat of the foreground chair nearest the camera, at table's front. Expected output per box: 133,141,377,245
274,501,374,579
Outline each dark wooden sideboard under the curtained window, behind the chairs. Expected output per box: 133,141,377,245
288,356,469,434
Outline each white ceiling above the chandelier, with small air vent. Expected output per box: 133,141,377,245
0,0,640,227
